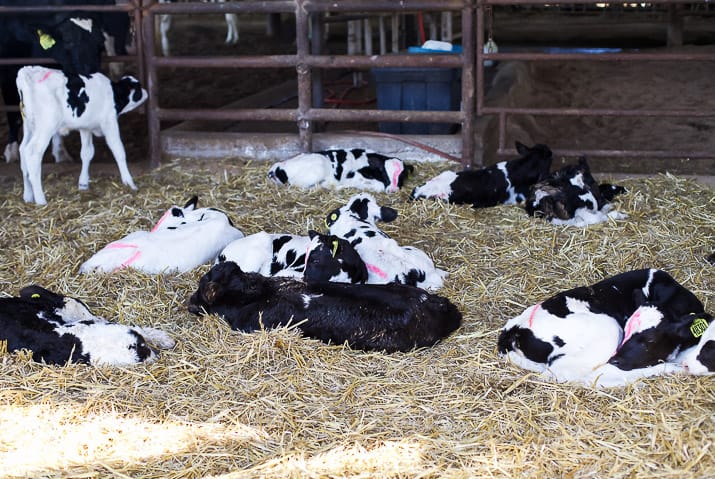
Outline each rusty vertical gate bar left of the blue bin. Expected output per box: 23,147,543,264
295,0,313,152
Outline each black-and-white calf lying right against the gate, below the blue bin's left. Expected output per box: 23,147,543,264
268,148,414,193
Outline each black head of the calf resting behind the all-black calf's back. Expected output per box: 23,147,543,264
303,230,367,283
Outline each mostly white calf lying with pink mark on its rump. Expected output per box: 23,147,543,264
79,196,243,274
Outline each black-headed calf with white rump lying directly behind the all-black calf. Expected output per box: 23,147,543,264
218,231,367,283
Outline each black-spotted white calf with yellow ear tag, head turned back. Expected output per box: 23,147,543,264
325,193,447,290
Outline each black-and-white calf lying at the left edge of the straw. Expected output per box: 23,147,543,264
0,286,174,366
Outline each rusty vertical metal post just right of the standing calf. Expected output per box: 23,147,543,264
142,0,161,168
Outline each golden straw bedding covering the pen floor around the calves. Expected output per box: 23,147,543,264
0,161,715,479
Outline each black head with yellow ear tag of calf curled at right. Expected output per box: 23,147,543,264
608,303,713,371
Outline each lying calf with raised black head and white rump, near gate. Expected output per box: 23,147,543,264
410,141,553,208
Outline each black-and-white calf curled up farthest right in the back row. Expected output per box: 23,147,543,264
524,157,626,226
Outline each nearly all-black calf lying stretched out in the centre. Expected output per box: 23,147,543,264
189,261,462,352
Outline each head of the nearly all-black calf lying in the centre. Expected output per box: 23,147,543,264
188,261,266,315
